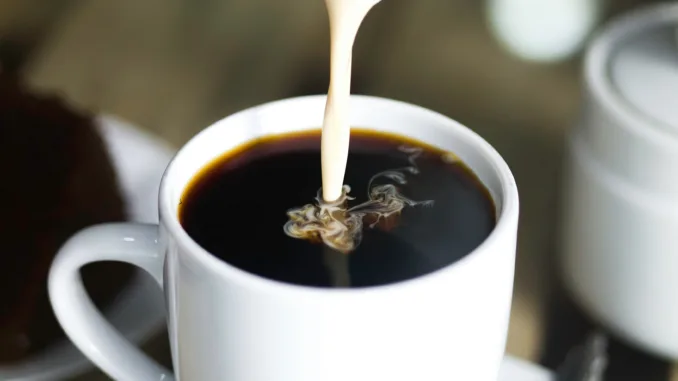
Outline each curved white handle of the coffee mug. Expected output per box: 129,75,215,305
48,223,174,381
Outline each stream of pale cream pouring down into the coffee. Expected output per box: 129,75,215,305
320,0,379,203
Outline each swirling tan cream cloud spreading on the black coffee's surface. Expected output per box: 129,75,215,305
283,146,433,253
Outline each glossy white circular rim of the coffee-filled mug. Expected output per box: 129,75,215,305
158,94,519,297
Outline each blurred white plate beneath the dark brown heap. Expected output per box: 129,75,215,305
0,117,174,381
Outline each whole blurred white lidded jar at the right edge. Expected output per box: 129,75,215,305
561,4,678,359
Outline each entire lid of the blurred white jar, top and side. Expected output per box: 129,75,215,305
575,3,678,196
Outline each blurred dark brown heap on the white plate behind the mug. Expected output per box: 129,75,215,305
0,73,131,364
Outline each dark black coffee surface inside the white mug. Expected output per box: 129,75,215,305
179,129,496,287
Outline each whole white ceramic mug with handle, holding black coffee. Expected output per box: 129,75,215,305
49,96,518,381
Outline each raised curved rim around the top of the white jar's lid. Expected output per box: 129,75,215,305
584,3,678,146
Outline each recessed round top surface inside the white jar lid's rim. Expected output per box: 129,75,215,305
608,22,678,134
